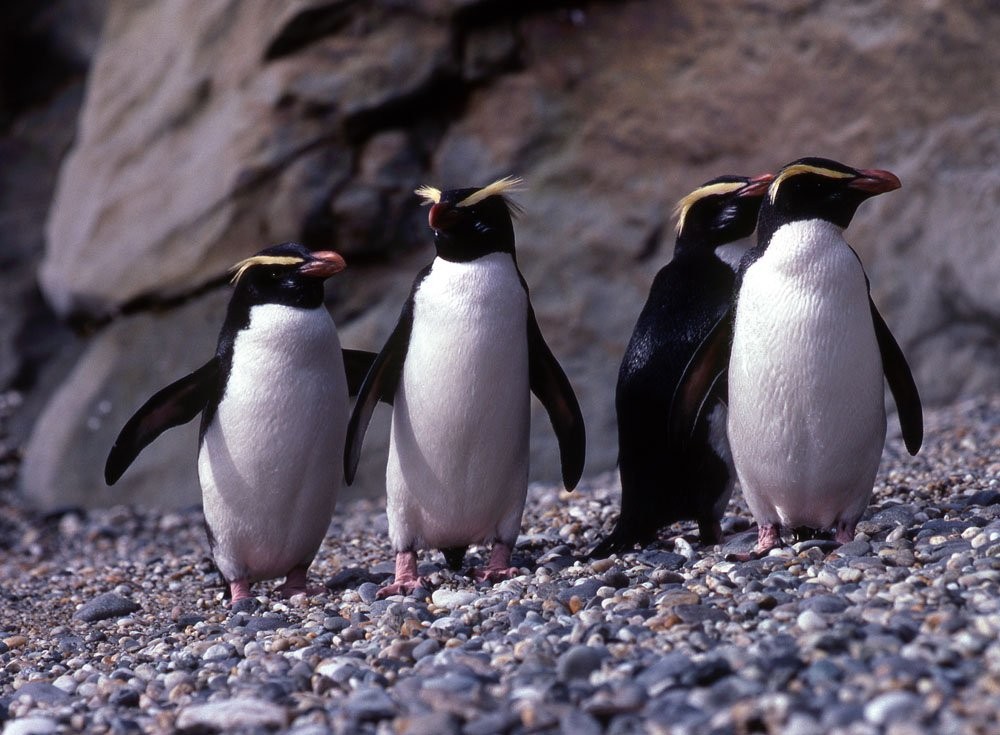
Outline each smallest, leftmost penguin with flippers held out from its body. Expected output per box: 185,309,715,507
104,243,375,608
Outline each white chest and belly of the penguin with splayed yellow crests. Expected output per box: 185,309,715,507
386,253,530,549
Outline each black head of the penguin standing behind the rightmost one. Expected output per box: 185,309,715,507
674,174,774,254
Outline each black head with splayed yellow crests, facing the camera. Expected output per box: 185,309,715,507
416,176,521,262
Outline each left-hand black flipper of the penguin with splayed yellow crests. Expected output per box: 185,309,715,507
344,300,412,485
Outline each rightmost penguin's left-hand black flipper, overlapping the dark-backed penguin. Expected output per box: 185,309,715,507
667,308,733,447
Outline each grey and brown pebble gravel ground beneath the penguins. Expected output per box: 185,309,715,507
0,394,1000,735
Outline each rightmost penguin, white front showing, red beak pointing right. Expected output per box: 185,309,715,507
685,158,923,555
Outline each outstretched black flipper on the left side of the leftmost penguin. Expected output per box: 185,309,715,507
104,357,219,485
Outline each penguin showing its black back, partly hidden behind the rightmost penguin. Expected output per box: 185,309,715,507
590,174,773,557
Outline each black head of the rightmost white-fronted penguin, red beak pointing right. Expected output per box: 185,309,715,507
758,158,901,238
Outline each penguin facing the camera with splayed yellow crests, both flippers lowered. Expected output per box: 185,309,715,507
345,177,586,598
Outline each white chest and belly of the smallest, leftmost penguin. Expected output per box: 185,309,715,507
198,304,347,580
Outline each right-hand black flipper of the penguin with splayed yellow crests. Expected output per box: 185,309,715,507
528,305,587,490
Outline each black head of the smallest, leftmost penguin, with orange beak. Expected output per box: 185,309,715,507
230,242,347,309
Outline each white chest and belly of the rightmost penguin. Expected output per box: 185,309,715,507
728,220,885,528
